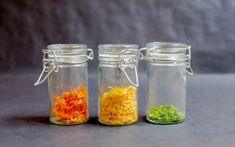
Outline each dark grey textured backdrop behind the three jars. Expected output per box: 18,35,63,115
0,0,235,73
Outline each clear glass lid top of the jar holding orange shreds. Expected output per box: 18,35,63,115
47,44,87,51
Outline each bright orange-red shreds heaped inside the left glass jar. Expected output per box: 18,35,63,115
51,86,88,124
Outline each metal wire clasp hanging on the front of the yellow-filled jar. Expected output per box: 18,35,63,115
117,49,139,87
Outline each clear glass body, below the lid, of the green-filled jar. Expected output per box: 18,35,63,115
146,62,186,124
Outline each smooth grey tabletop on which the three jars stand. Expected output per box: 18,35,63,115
0,74,235,147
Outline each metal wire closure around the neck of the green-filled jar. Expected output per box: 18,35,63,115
138,46,195,76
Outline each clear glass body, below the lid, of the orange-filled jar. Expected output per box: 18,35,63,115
48,62,89,125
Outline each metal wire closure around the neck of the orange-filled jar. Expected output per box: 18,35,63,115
34,49,94,86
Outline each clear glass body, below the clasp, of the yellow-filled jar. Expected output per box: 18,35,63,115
98,63,138,125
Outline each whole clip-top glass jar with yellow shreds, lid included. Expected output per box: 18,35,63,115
98,44,139,125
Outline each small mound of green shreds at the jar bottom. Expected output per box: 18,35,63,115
147,105,184,124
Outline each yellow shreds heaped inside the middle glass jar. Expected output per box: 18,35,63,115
99,86,137,125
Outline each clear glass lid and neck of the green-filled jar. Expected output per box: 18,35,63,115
145,42,191,63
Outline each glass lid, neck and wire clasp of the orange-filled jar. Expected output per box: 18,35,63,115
34,44,94,86
